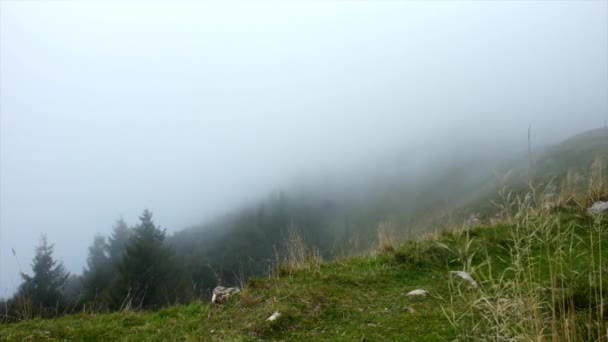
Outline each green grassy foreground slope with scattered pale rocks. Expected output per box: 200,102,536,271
0,209,608,341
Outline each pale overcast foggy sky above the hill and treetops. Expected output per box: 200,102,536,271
0,0,608,297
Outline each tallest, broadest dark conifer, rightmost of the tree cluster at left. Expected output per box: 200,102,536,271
116,209,181,308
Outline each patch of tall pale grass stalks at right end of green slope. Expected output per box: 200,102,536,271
444,190,608,341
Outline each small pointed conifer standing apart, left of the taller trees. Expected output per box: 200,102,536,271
18,234,69,309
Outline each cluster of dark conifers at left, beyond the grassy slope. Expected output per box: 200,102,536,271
0,210,188,321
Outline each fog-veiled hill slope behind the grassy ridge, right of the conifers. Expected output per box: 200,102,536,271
170,129,608,295
